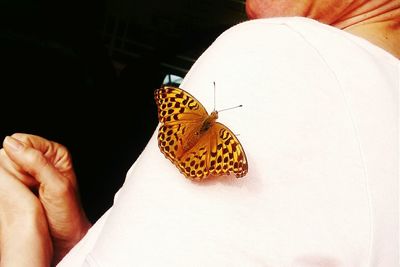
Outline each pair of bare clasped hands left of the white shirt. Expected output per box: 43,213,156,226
0,134,91,266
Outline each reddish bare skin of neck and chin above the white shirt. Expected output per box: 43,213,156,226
246,0,400,58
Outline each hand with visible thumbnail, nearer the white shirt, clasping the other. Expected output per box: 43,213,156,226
3,134,91,263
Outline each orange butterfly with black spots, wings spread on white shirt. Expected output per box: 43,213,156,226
154,86,248,180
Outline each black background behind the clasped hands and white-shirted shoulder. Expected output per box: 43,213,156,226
0,0,246,222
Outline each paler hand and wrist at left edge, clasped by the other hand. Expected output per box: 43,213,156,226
0,143,52,267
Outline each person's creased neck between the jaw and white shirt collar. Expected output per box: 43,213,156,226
332,1,400,58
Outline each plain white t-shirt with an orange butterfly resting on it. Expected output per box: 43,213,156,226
59,17,400,267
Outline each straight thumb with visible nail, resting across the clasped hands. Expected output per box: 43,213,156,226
3,136,67,192
